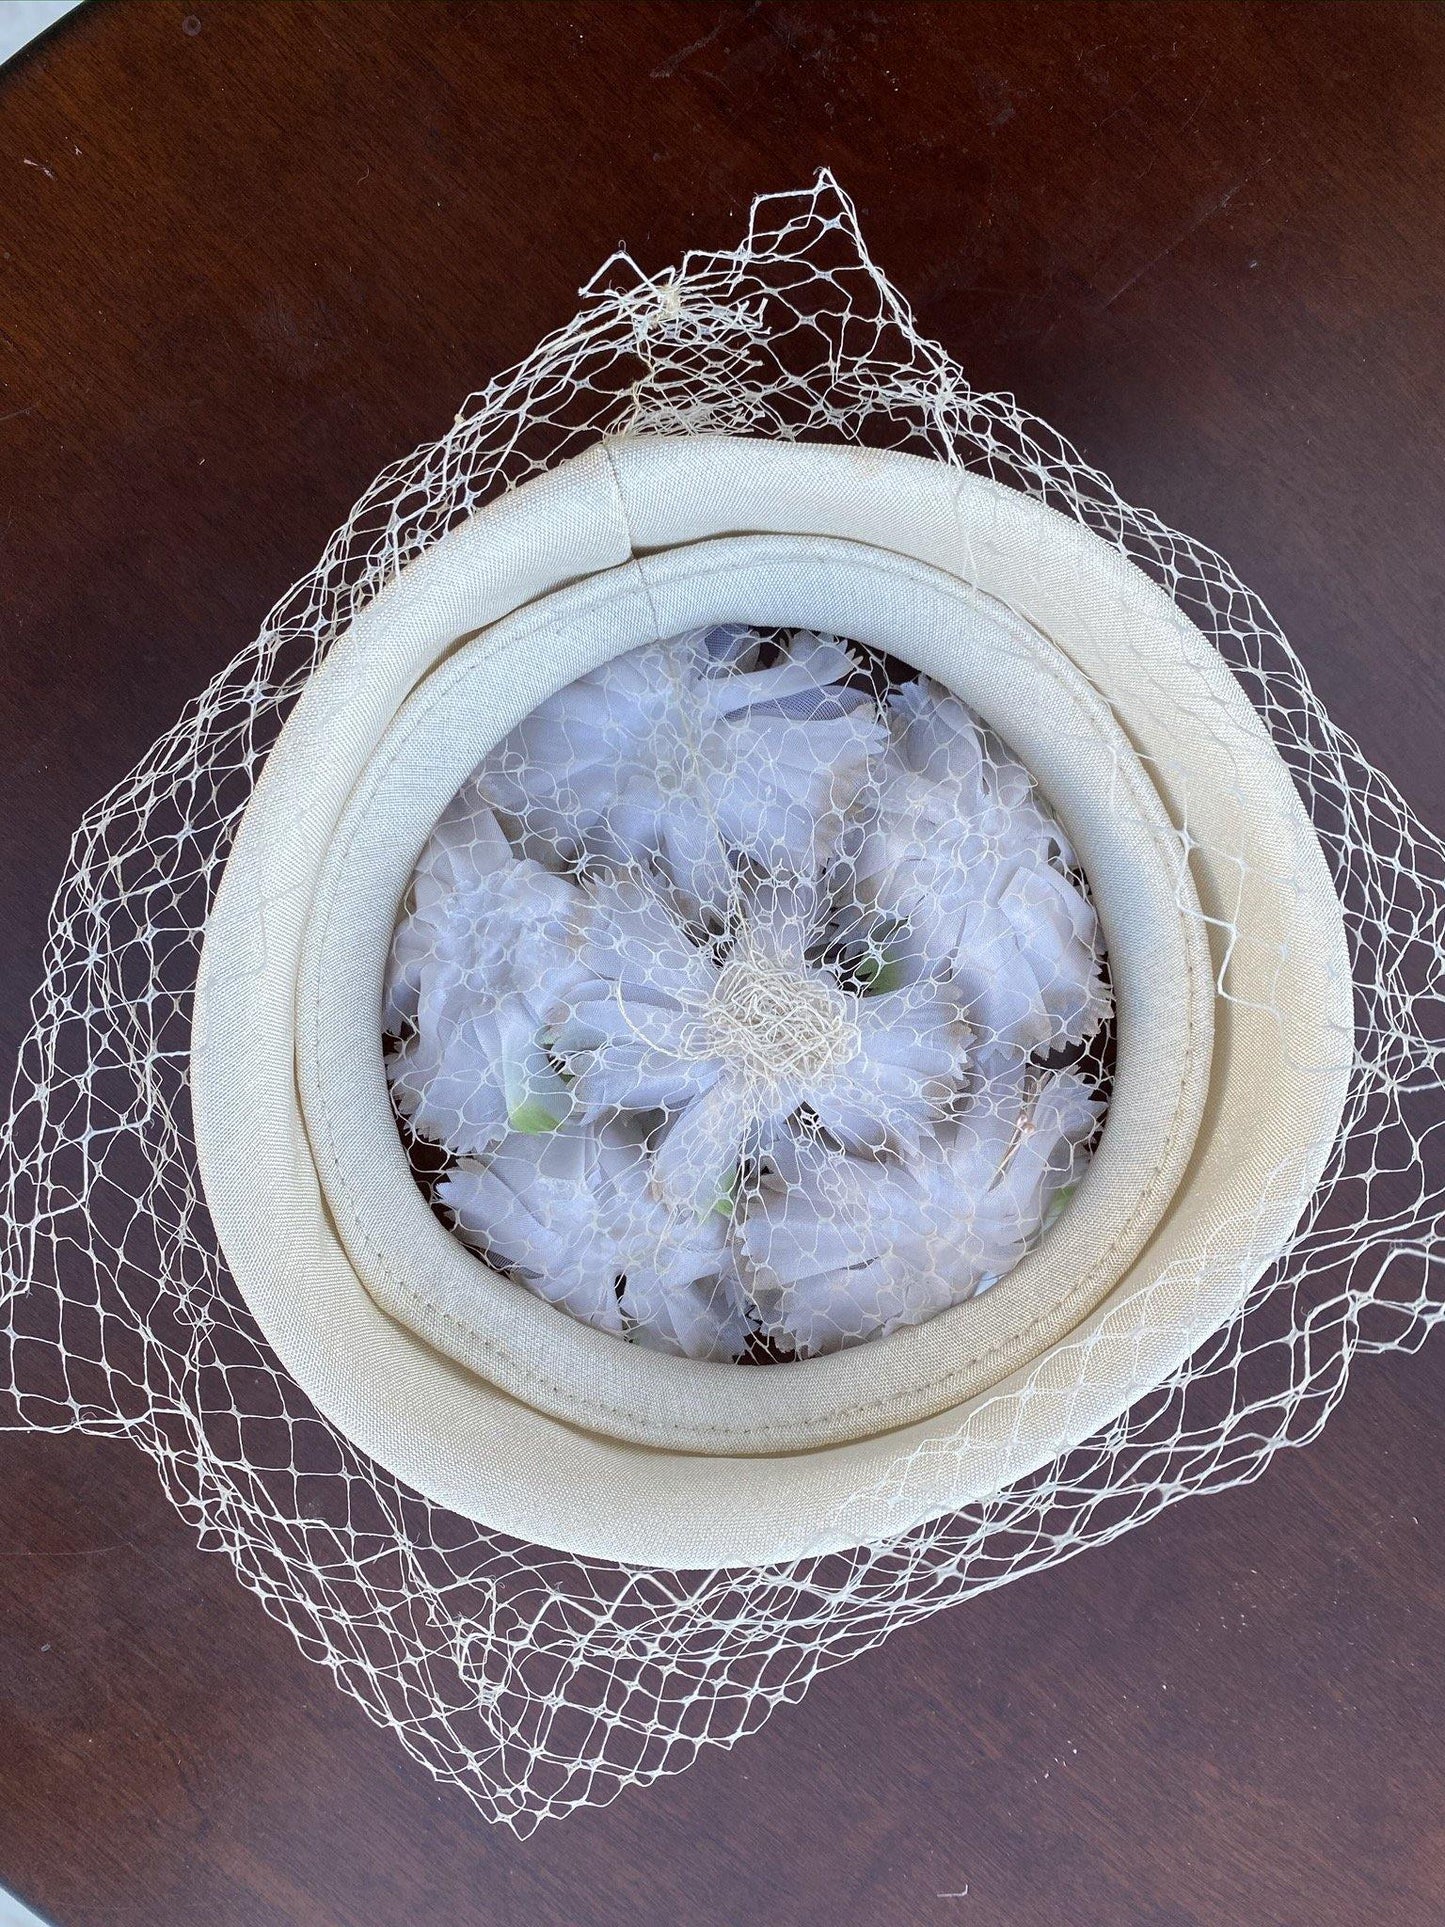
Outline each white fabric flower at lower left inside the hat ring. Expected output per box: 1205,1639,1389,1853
437,1122,749,1359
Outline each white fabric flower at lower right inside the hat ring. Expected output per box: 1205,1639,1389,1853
736,1062,1102,1357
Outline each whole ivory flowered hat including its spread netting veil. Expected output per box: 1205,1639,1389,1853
2,175,1445,1831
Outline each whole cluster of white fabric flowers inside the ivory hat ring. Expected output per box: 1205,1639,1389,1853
385,626,1110,1359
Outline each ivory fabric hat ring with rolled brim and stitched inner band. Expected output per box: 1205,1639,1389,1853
193,436,1351,1567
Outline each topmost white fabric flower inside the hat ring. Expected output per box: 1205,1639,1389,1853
478,626,886,917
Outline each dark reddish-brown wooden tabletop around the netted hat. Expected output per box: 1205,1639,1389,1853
0,0,1445,1927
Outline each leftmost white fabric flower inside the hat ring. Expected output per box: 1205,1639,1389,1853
385,784,588,1154
